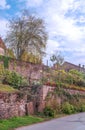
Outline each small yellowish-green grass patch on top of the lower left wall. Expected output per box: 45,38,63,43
0,83,18,93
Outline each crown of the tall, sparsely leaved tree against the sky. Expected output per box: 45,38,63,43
6,11,47,59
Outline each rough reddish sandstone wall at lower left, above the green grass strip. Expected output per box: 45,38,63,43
0,93,34,119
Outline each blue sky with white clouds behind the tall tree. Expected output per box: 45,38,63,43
0,0,85,65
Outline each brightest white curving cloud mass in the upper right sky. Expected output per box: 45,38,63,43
43,0,83,41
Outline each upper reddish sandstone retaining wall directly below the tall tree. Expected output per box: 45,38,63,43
9,59,42,80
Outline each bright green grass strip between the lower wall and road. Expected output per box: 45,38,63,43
0,116,44,130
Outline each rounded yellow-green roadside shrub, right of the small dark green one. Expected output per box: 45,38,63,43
62,102,74,114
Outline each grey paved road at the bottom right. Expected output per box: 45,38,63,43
16,113,85,130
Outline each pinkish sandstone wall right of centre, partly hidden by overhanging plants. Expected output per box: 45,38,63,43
36,85,85,112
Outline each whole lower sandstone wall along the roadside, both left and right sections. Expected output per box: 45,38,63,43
0,85,85,119
